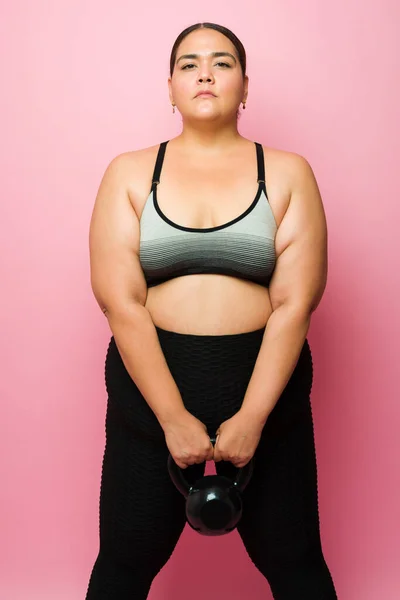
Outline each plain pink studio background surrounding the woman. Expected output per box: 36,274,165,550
0,0,400,600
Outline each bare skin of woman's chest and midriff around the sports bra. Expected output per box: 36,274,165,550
128,138,292,335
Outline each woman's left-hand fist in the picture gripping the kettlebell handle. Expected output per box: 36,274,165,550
163,410,214,469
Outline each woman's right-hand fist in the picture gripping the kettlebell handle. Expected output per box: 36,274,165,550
214,410,264,468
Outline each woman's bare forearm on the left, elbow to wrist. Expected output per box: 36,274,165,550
107,304,186,429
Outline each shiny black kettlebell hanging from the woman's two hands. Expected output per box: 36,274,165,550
168,438,254,535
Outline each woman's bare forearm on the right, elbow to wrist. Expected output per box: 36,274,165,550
240,305,311,424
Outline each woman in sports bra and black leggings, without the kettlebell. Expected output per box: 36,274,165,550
86,23,336,600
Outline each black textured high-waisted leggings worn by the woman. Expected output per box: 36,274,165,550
86,327,337,600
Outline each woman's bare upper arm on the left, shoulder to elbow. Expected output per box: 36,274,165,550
89,154,147,312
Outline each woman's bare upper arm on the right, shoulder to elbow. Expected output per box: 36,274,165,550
269,154,327,313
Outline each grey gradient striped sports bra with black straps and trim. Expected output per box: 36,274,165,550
139,140,277,287
